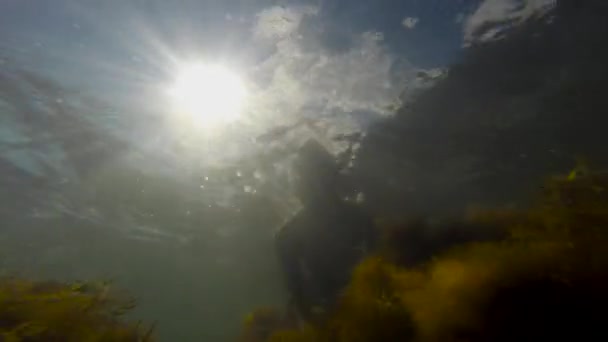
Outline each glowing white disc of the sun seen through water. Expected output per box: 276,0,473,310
169,63,247,127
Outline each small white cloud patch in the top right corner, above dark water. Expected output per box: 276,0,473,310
463,0,557,46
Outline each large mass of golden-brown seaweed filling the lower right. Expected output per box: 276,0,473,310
254,173,608,342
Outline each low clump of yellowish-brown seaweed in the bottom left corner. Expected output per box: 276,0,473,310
0,277,154,342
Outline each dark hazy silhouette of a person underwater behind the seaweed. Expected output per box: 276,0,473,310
276,140,375,321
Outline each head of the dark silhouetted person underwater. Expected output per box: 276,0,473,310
294,140,339,204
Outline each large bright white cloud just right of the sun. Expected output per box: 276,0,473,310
245,7,414,153
